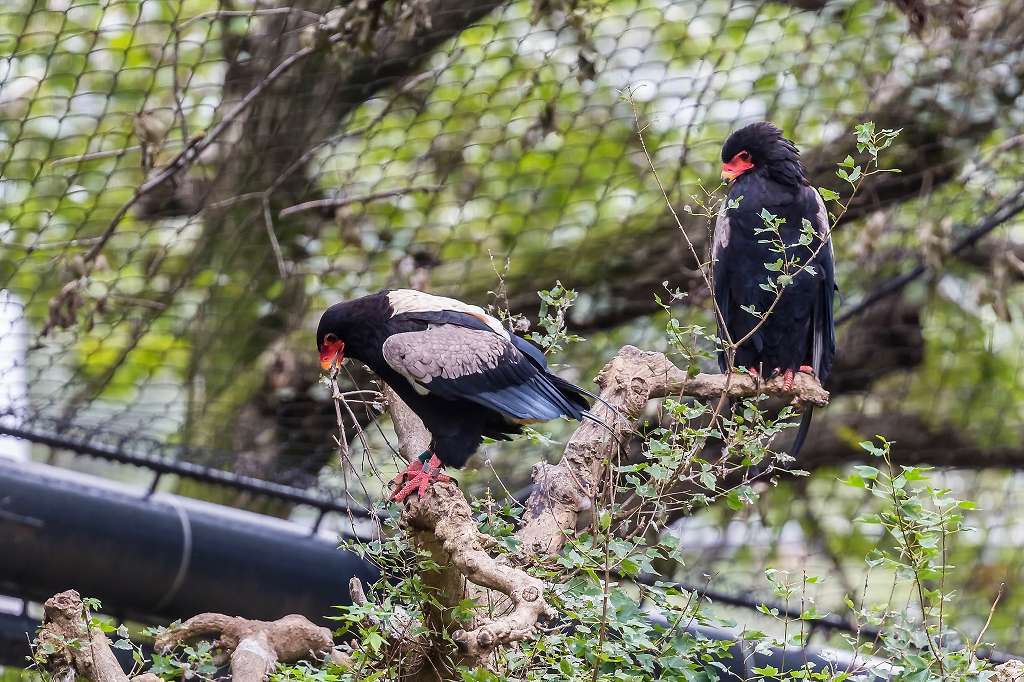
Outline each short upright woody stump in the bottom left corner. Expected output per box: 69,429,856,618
33,590,128,682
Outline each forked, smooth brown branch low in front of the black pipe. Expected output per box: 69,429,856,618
155,613,334,682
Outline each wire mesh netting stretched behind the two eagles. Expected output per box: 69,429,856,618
0,0,1024,648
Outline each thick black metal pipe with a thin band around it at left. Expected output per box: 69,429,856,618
0,460,377,624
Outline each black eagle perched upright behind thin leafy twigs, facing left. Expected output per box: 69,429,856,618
712,123,836,456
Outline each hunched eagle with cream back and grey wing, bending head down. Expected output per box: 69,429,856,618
316,289,590,501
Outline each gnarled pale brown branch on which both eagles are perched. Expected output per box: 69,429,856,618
387,346,828,664
